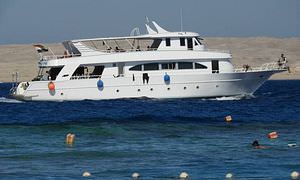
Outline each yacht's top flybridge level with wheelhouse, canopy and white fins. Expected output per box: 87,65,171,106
67,21,204,55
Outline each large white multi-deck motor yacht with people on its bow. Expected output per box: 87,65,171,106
10,21,286,101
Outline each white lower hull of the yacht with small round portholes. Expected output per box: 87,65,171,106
11,70,279,101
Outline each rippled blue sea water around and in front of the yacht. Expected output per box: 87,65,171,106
0,80,300,180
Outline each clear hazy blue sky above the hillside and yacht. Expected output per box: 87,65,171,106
0,0,300,44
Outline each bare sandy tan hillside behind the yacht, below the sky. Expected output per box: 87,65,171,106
0,37,300,82
